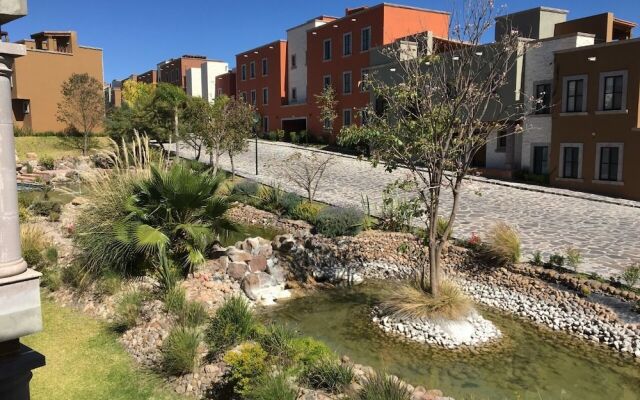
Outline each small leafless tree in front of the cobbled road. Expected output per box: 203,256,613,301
281,152,333,201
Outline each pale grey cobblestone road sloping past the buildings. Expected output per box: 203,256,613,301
174,141,640,276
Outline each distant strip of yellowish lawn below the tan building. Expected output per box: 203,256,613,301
15,136,110,160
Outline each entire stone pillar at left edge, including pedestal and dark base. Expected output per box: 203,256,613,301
0,39,45,400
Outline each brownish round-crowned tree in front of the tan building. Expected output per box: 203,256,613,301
57,73,105,155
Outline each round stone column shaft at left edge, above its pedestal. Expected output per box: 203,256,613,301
0,49,27,279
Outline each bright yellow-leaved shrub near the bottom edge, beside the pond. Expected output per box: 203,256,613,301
224,342,267,396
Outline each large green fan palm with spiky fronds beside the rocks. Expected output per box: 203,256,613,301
115,164,236,272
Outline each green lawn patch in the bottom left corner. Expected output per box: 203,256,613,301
23,296,185,400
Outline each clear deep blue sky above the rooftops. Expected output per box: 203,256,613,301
2,0,640,82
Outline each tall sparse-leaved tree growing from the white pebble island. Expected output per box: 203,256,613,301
339,0,524,296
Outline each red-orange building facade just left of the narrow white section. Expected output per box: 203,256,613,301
236,40,287,132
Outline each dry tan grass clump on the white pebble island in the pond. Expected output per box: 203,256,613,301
382,281,472,319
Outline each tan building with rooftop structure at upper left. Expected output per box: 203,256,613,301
11,31,103,132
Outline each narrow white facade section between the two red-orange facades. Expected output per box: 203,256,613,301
287,16,335,104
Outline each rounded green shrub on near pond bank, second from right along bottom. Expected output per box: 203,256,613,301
300,359,354,393
